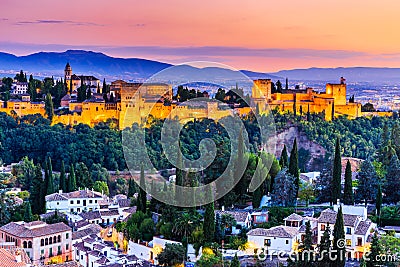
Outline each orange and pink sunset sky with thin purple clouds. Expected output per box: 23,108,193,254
0,0,400,72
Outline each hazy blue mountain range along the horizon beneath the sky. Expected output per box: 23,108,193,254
0,50,400,83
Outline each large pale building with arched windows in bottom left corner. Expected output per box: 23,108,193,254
0,221,72,264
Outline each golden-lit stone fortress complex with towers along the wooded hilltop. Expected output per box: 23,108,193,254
0,64,361,129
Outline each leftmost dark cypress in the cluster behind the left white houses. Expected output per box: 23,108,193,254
29,164,45,214
